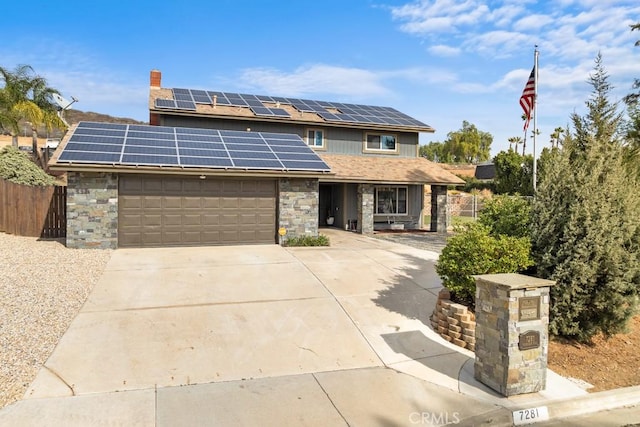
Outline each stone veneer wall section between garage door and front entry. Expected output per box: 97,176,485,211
278,178,319,238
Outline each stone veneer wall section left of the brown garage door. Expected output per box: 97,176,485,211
67,172,118,249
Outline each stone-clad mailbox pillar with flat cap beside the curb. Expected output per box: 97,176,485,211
474,274,554,396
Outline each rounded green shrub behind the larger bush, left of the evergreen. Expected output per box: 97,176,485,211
478,195,531,237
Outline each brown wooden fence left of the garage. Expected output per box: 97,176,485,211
0,180,67,238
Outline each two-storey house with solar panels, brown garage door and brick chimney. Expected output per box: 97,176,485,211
50,70,462,248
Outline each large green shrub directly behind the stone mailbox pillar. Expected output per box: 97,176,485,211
436,223,532,306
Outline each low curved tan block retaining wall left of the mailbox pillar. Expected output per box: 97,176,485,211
431,289,476,351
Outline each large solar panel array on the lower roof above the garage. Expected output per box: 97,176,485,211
58,122,330,172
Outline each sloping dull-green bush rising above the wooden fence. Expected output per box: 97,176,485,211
0,146,56,185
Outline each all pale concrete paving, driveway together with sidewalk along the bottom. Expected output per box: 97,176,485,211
0,229,640,426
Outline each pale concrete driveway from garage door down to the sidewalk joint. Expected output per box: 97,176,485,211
26,230,448,398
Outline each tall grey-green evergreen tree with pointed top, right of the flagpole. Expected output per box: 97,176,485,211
532,55,640,341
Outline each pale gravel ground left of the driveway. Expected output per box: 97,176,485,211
0,232,112,408
